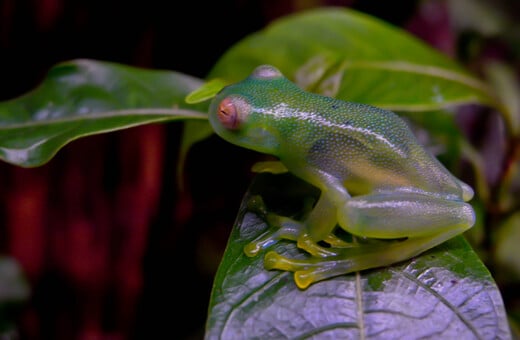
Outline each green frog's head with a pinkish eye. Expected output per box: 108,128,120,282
209,65,288,155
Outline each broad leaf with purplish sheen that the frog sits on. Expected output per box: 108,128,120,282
205,174,511,339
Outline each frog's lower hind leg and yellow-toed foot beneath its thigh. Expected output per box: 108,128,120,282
264,229,460,289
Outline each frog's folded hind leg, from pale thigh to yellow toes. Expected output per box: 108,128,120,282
264,192,475,288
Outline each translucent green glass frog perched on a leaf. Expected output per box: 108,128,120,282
209,65,475,289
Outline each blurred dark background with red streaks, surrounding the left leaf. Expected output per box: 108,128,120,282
0,0,516,339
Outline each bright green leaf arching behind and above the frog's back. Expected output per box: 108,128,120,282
210,7,498,111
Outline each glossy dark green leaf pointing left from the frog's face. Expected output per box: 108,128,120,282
0,60,207,167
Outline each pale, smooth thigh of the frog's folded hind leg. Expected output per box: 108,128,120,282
338,192,475,238
